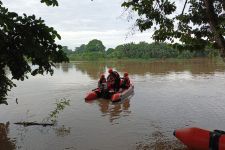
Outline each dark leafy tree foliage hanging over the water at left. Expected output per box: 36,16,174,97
0,0,68,103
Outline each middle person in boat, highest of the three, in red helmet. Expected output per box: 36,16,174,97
107,68,120,92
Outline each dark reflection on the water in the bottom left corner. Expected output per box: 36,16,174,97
0,122,16,150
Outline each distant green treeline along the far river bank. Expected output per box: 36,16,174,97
63,39,219,60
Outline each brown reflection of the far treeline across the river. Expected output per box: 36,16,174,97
56,59,225,79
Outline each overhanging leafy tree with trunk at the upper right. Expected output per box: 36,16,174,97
122,0,225,57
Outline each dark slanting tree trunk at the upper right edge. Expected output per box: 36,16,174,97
204,0,225,58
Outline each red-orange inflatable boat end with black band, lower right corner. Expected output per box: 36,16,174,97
174,128,225,150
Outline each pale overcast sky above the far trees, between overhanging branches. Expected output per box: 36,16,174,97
2,0,152,50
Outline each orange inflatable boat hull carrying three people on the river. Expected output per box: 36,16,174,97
85,84,134,102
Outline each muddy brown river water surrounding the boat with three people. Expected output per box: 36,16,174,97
0,59,225,150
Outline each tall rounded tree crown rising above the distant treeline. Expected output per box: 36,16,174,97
86,39,105,52
